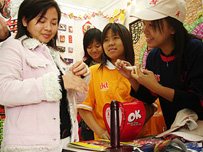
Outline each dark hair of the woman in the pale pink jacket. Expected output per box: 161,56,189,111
15,0,61,49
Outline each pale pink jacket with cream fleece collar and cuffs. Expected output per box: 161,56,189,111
0,38,89,151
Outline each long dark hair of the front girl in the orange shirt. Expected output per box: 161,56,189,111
100,23,135,69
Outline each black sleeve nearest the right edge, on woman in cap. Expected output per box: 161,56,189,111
173,40,203,112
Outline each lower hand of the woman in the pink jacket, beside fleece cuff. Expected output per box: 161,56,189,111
62,73,88,93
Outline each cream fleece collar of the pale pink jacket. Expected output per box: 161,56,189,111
19,35,44,50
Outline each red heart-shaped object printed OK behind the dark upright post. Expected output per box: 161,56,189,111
103,100,145,141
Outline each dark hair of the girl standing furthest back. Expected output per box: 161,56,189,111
83,28,101,66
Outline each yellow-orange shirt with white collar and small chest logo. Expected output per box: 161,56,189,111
78,62,136,139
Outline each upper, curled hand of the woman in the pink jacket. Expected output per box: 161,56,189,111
70,61,90,76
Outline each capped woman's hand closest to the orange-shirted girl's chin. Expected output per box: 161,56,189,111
115,59,132,79
